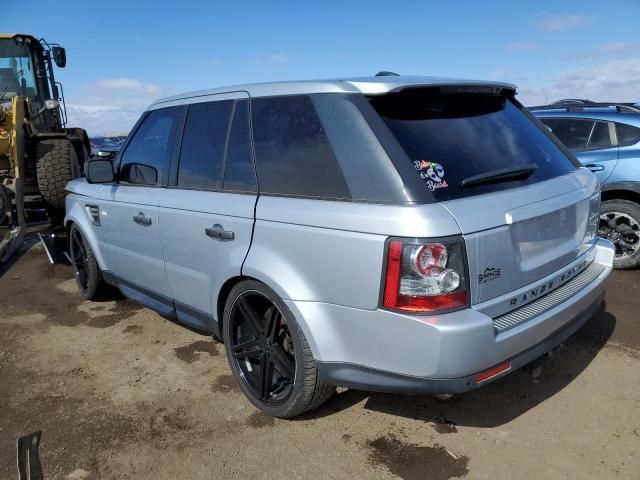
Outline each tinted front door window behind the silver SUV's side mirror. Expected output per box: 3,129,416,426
120,107,178,185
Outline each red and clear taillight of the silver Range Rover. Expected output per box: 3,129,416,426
382,238,469,313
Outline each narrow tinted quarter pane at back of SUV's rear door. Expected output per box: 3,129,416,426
224,100,256,192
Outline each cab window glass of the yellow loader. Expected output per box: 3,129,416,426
0,38,36,99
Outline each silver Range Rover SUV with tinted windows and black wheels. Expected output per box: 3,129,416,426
65,76,614,417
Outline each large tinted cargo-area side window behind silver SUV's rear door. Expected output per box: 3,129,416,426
252,95,351,199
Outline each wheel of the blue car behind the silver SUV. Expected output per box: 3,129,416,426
598,199,640,269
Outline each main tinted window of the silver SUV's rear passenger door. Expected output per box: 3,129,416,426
178,100,234,189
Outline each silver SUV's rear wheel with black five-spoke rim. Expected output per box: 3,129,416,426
223,280,335,418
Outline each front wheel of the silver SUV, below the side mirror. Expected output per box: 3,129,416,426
69,224,111,300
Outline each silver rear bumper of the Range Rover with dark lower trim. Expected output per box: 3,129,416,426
286,240,613,393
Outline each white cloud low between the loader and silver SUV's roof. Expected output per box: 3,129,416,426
67,77,173,135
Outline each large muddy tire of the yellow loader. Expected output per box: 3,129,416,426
36,138,79,219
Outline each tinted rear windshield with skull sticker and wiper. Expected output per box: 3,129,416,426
370,89,576,201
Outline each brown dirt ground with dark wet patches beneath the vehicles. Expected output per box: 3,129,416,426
0,238,640,480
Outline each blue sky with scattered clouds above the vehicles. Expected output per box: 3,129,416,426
0,0,640,134
